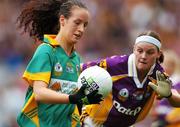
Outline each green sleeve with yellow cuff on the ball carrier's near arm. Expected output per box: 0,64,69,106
23,44,52,85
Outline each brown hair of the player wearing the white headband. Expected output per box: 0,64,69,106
138,31,164,63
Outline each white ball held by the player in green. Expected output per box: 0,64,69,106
78,66,112,98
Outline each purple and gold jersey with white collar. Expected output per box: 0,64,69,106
82,54,163,127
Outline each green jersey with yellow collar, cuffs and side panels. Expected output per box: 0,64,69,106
17,35,80,127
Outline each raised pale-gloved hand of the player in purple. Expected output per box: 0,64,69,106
148,71,172,98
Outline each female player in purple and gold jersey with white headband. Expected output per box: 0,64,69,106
81,31,171,127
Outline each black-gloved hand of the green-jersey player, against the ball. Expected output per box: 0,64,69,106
69,85,102,105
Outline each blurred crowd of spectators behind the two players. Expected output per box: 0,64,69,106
0,0,180,127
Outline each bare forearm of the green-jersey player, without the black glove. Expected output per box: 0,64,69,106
33,81,69,104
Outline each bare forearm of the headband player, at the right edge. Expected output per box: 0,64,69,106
168,90,180,107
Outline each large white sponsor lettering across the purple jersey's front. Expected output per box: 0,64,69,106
113,100,141,116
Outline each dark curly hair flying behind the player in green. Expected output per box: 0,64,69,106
17,0,87,40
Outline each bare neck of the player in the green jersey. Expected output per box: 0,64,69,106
55,34,74,56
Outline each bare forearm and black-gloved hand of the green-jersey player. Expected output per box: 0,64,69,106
33,81,102,105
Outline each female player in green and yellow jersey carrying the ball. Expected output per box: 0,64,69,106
17,0,101,127
